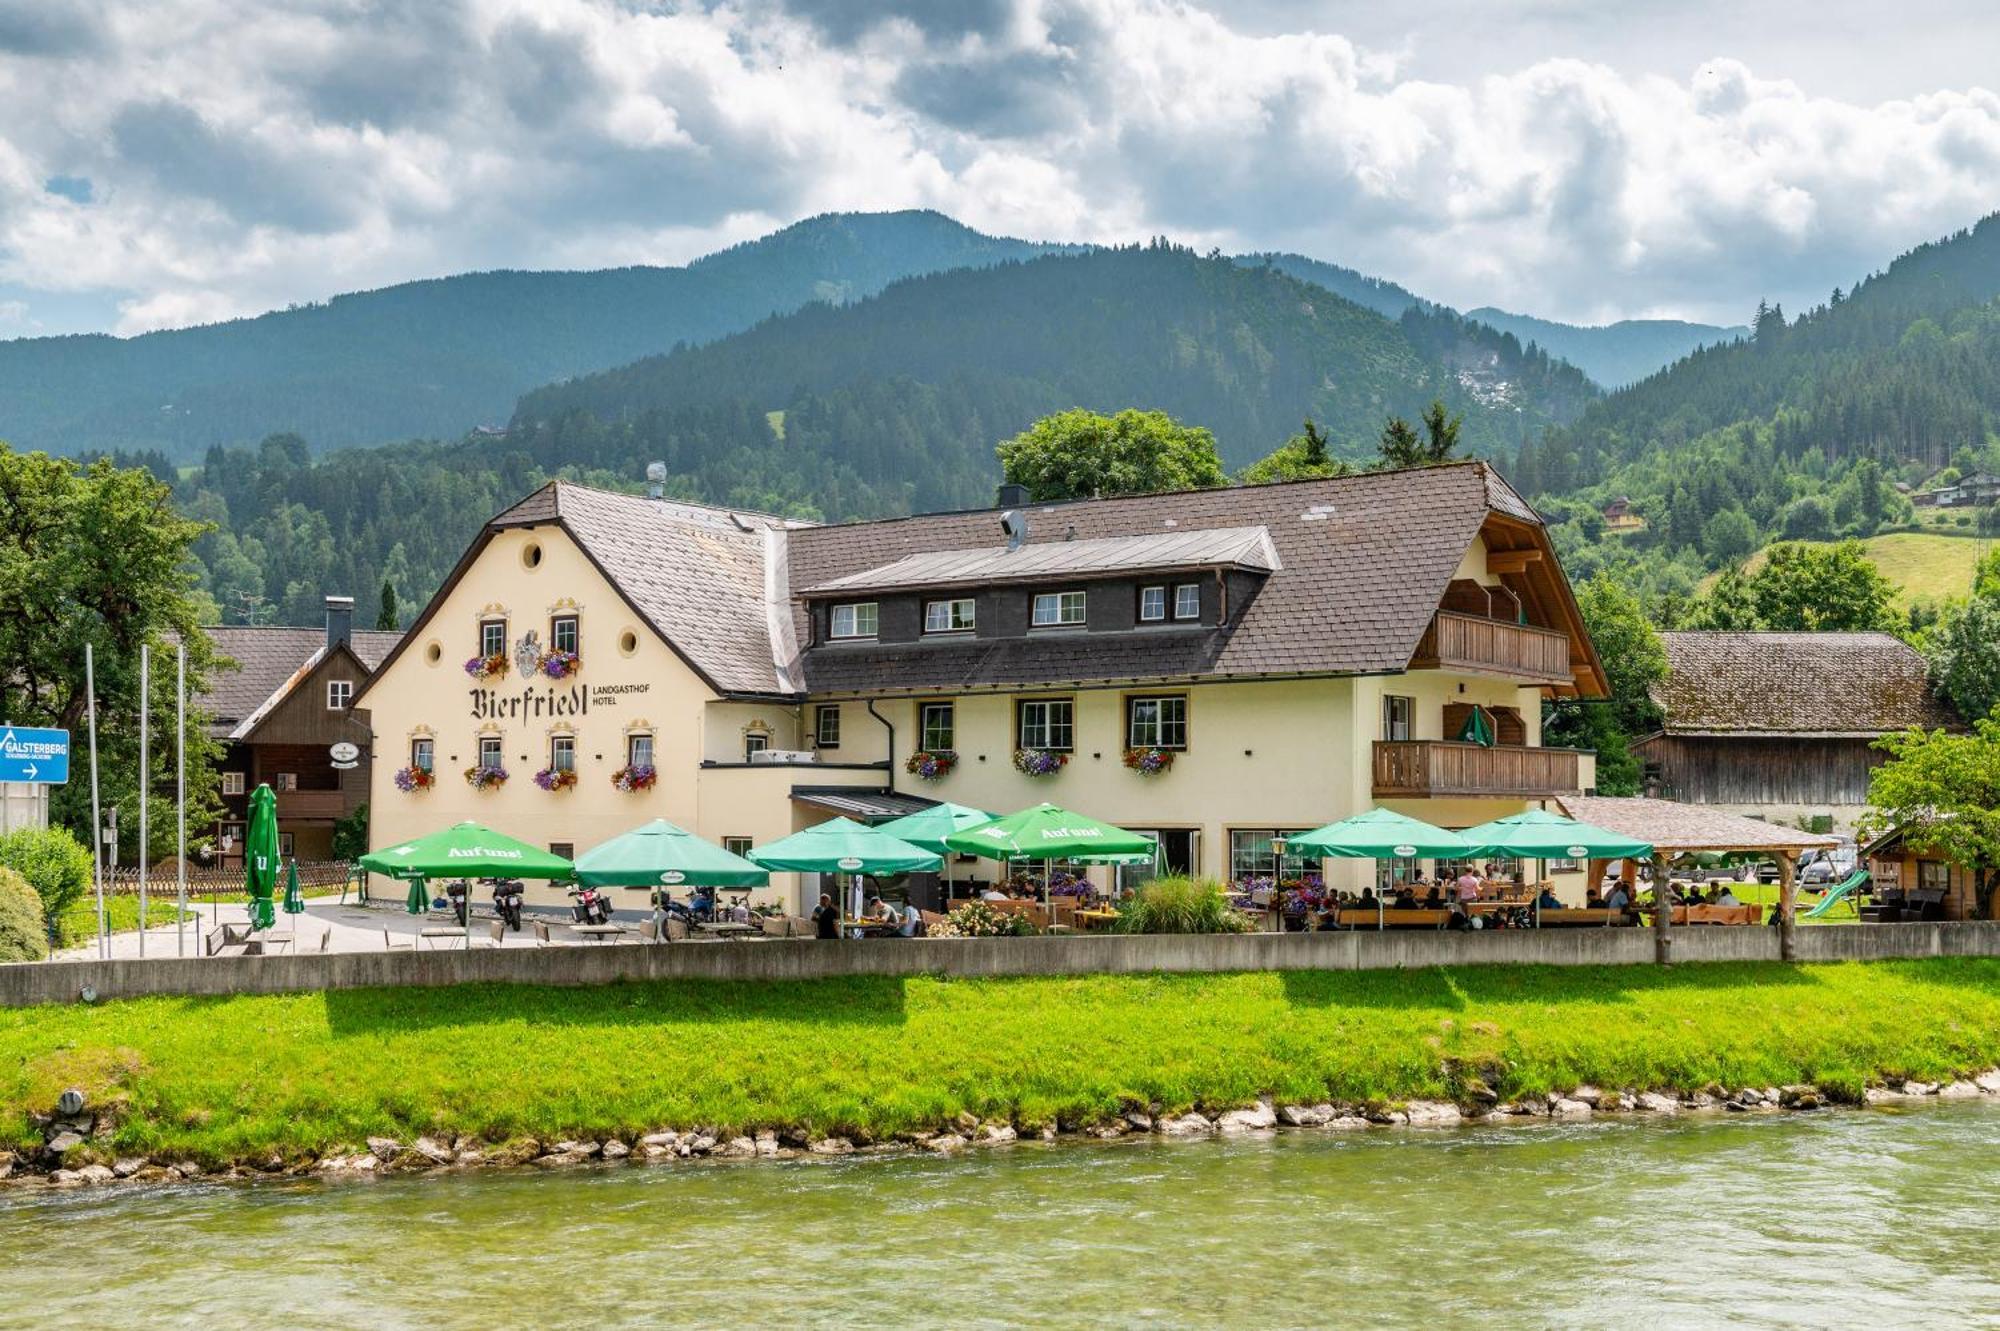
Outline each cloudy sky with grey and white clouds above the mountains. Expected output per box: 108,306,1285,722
0,0,2000,338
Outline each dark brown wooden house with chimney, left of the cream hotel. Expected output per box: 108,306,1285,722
196,596,402,867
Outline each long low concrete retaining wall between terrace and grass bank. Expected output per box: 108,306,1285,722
0,921,2000,1007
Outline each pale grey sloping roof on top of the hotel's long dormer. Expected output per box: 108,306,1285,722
794,528,1278,596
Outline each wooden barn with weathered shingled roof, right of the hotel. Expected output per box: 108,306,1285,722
1632,632,1956,829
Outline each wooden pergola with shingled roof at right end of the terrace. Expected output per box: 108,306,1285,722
1556,795,1840,965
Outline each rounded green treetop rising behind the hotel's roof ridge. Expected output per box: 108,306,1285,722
998,408,1228,504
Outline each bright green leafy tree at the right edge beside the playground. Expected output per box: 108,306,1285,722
1862,717,2000,917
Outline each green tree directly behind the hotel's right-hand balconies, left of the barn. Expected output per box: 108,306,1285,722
1542,574,1666,795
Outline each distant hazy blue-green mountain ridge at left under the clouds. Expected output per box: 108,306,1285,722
0,212,1062,462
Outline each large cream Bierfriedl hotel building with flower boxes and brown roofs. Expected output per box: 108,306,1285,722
362,464,1606,909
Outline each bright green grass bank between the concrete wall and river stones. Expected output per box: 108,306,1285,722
0,959,2000,1163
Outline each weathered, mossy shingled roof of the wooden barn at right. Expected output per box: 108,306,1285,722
1652,630,1956,739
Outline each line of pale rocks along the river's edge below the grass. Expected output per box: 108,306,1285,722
0,1067,2000,1189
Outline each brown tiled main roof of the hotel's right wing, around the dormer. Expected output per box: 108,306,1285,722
786,464,1540,693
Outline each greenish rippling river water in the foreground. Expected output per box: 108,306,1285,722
0,1103,2000,1331
